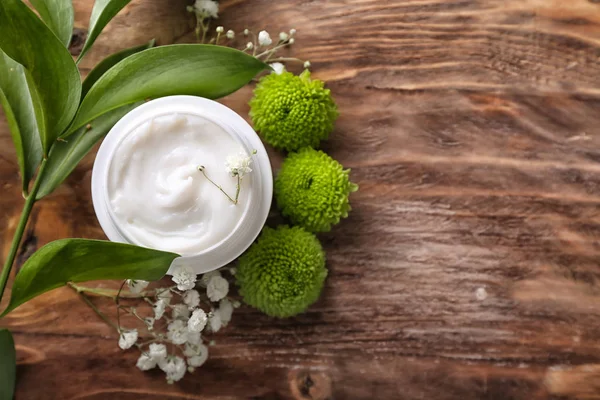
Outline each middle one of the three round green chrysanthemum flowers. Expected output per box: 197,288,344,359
275,148,358,232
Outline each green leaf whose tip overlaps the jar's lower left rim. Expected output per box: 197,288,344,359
2,239,179,316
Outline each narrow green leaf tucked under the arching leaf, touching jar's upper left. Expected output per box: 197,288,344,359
36,103,142,200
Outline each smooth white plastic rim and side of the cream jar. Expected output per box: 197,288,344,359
92,96,273,274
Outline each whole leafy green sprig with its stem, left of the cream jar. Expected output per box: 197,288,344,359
0,0,268,390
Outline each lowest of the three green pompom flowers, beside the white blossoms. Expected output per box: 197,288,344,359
236,225,327,318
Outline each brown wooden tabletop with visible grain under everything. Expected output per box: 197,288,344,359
0,0,600,400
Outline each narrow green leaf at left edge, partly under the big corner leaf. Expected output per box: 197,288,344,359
0,50,42,193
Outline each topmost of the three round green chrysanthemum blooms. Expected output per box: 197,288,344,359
250,70,338,151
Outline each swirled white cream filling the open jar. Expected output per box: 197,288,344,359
107,114,252,256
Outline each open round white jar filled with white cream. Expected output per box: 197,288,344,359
92,96,273,274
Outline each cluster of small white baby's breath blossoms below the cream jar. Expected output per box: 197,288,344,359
119,267,239,383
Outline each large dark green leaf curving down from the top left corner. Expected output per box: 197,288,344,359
0,0,81,154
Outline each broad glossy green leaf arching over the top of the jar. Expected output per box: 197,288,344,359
65,44,269,136
